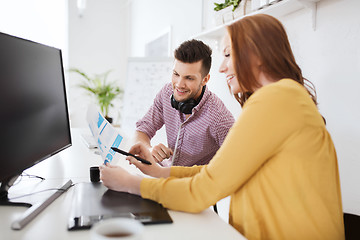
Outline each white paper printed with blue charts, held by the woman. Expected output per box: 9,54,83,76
86,105,123,164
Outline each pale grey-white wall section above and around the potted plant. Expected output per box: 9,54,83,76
67,0,129,127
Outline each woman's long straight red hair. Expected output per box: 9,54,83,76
227,14,317,106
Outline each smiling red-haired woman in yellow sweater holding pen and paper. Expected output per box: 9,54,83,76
101,14,344,239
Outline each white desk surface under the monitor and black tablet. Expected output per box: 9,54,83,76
0,129,245,240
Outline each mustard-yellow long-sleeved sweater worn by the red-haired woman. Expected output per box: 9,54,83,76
141,79,344,240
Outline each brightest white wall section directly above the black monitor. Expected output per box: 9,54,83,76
0,0,68,86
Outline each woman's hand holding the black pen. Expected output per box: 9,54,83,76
126,143,170,178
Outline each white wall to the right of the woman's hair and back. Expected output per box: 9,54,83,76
284,0,360,214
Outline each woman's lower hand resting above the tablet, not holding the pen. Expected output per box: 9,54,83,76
100,163,142,195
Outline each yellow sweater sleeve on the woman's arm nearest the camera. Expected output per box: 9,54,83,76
140,80,310,212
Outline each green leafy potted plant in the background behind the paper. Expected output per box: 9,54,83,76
69,68,124,123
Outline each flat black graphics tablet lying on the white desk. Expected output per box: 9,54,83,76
68,183,172,230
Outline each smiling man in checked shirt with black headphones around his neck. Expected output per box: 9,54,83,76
136,40,234,166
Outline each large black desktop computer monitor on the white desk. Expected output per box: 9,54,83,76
0,33,71,205
